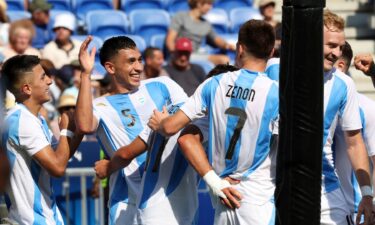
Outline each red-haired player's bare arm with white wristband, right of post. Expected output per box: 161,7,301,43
345,130,373,224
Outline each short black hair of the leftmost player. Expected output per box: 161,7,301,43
1,55,40,97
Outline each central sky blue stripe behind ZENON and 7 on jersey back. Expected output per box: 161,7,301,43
220,70,258,177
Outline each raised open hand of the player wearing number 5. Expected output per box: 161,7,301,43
78,36,96,75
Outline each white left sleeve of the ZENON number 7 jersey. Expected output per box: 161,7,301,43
181,78,212,121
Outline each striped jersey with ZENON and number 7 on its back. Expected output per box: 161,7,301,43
181,69,279,202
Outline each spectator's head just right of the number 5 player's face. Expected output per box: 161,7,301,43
141,47,168,80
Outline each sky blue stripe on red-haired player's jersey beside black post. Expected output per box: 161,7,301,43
322,76,346,192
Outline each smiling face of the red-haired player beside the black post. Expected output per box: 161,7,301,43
323,26,345,72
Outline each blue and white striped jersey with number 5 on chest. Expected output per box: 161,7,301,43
93,76,187,221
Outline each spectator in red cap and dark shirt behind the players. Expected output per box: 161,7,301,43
164,38,205,96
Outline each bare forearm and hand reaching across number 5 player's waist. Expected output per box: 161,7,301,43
95,136,147,179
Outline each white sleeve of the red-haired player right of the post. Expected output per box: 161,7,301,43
339,79,362,131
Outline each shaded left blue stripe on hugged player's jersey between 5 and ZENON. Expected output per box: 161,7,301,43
139,133,165,209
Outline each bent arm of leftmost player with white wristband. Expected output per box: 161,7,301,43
33,110,83,177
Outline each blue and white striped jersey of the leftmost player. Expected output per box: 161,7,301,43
2,104,64,225
